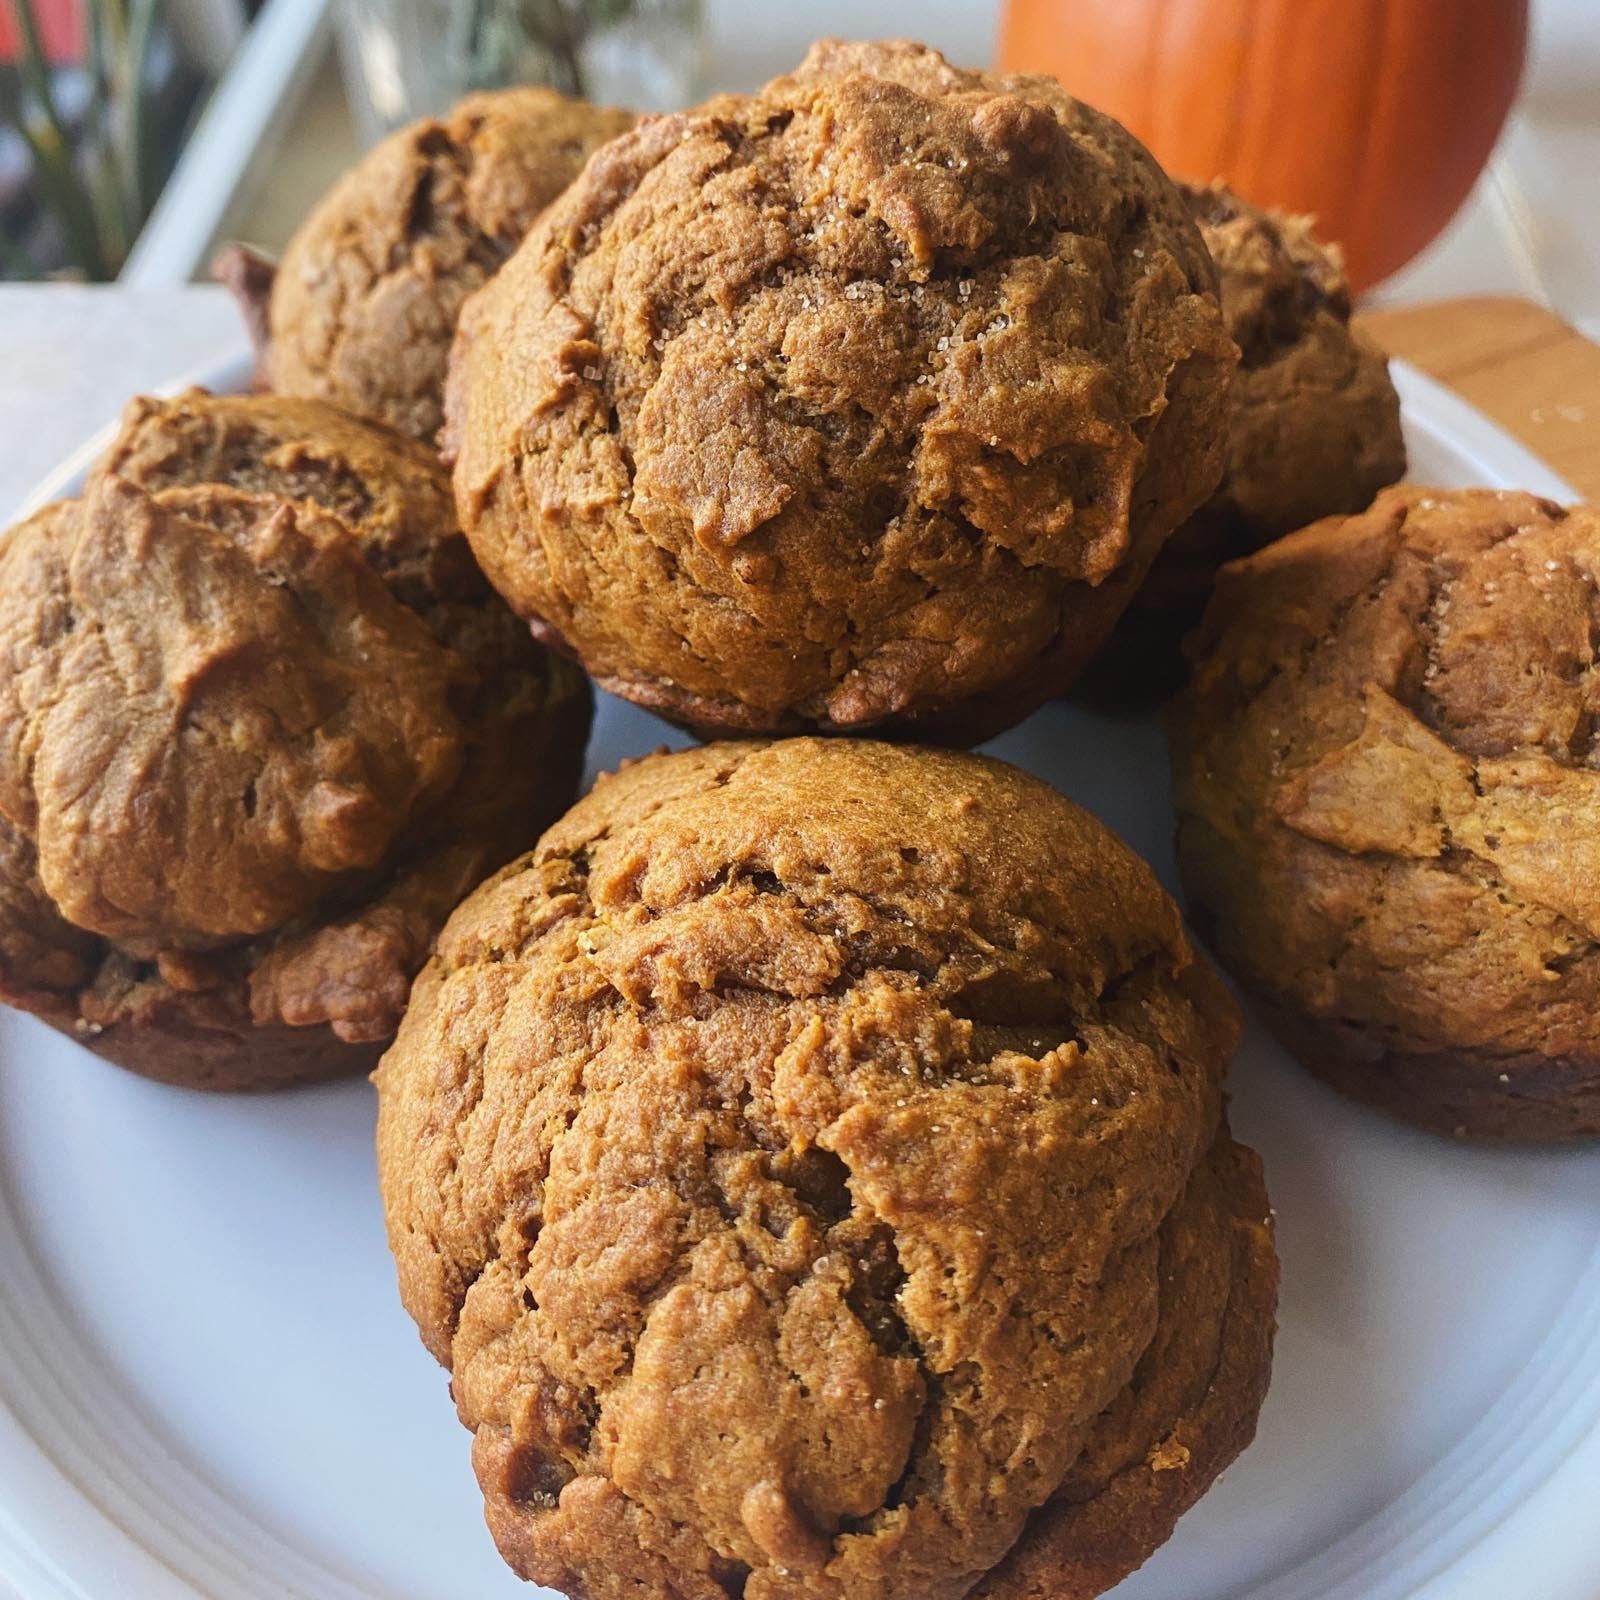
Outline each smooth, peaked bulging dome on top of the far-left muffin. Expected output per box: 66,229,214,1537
0,477,462,952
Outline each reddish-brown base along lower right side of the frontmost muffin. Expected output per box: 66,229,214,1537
968,1125,1278,1600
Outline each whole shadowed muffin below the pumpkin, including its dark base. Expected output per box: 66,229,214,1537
1083,184,1405,702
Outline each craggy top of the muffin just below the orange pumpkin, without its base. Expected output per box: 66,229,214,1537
1181,182,1405,534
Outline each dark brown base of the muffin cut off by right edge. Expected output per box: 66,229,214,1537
1253,994,1600,1144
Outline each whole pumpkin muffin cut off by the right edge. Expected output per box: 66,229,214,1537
1171,488,1600,1141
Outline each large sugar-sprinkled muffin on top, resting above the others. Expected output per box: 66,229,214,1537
443,43,1235,741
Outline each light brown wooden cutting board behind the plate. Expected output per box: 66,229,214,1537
1357,296,1600,501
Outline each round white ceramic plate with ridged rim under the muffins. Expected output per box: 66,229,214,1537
0,365,1600,1600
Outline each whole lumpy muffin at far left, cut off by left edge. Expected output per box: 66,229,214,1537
0,390,589,1088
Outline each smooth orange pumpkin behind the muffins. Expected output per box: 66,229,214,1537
1000,0,1528,288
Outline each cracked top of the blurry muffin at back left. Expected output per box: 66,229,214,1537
267,88,634,440
